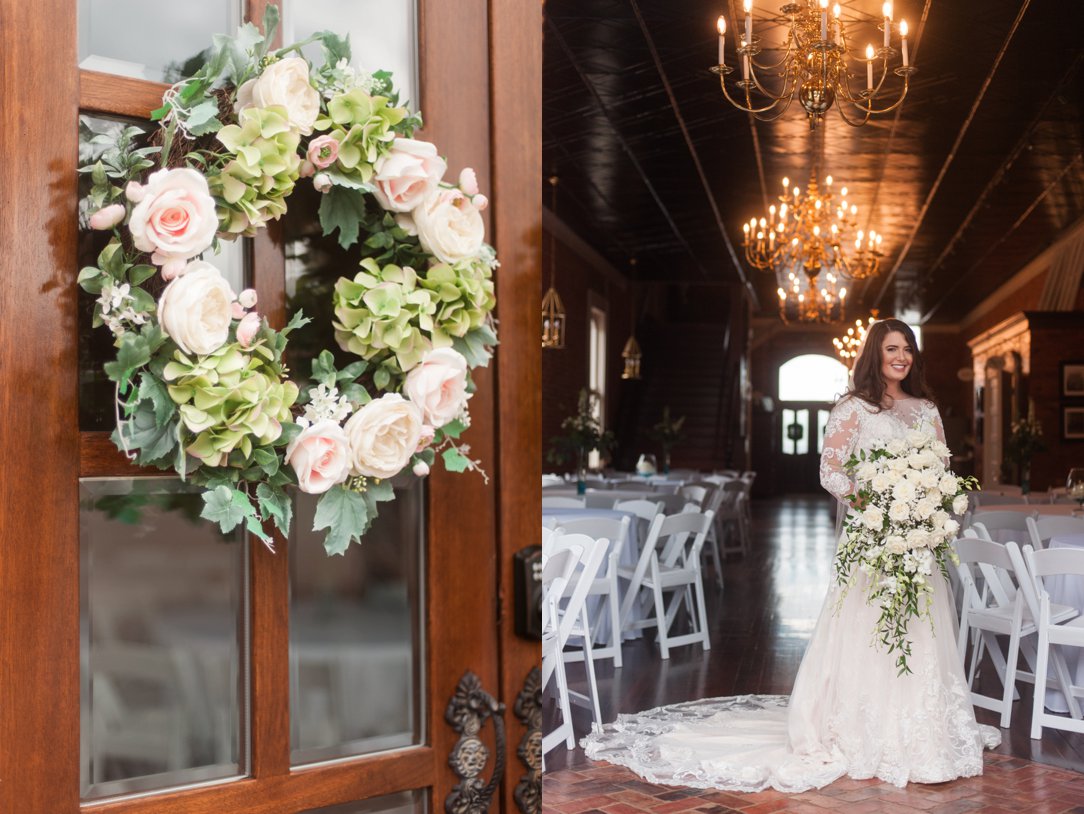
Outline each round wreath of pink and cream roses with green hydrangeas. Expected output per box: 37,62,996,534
78,5,498,554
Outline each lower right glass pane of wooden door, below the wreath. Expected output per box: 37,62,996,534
289,478,425,764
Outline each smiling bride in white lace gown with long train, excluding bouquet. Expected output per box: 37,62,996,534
583,320,1001,792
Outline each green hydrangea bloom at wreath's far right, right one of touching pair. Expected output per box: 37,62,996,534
422,260,496,347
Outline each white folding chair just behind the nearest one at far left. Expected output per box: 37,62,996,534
553,529,610,727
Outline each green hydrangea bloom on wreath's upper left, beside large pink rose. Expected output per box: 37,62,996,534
208,106,301,236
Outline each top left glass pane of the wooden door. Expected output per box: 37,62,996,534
79,0,241,83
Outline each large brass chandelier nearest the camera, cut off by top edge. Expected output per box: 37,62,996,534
711,0,915,128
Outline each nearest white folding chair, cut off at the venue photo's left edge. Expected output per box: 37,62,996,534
542,530,583,764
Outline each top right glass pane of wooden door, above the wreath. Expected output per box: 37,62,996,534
282,0,418,109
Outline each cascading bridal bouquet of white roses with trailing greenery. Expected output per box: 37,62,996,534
835,429,978,675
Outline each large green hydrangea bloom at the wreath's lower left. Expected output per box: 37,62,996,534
163,343,298,466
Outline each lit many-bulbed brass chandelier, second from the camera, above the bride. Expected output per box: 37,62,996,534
741,173,882,322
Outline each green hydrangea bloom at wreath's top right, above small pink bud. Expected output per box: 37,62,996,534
315,88,408,184
